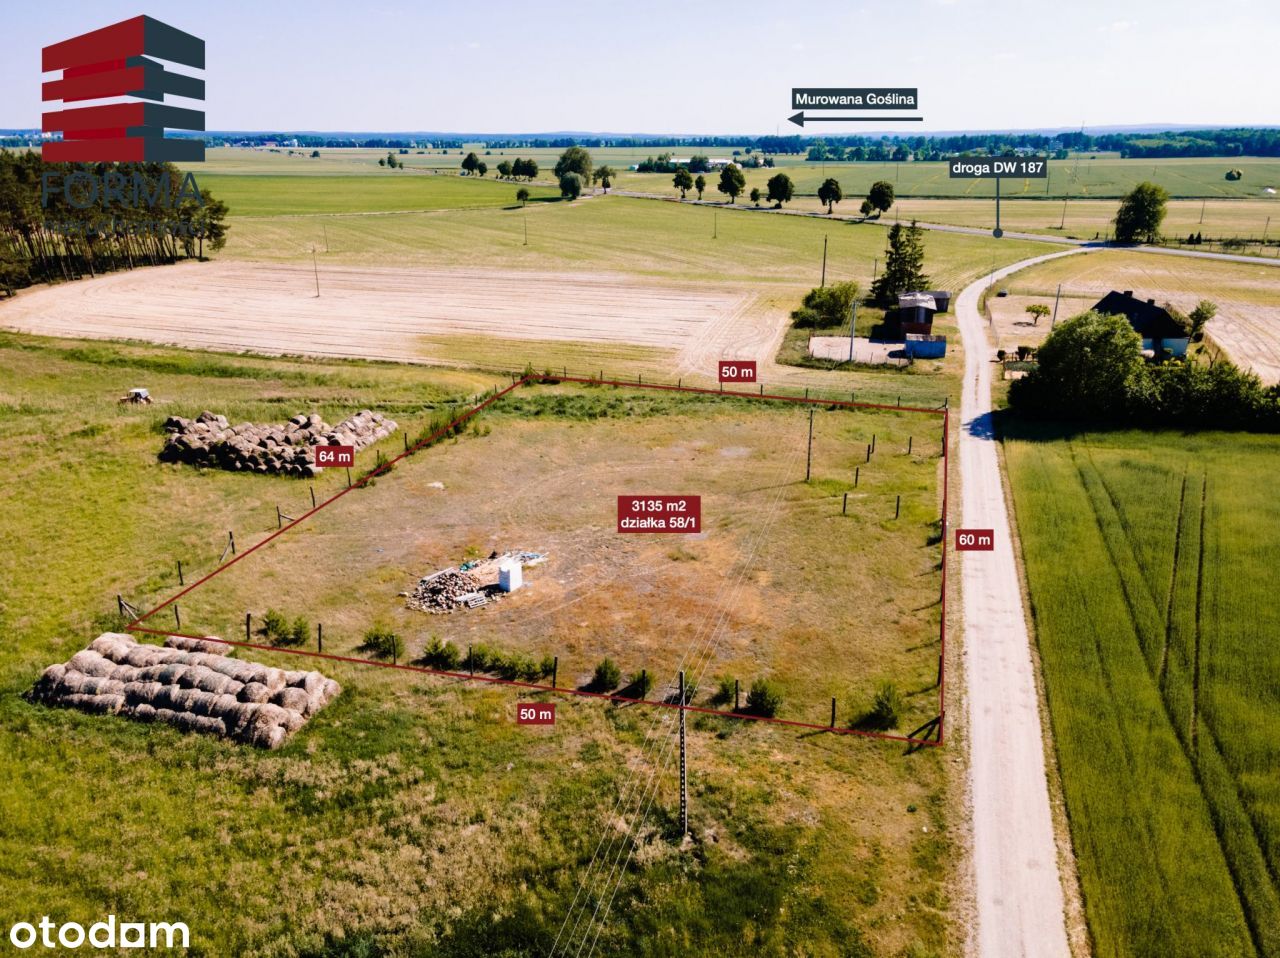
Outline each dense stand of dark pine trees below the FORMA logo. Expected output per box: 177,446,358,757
0,150,228,295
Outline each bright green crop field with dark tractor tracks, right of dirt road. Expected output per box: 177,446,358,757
1005,429,1280,958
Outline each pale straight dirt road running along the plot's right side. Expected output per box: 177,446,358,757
956,250,1078,958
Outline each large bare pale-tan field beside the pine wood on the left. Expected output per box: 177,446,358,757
0,263,749,366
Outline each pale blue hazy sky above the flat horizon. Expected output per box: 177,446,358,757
0,0,1280,136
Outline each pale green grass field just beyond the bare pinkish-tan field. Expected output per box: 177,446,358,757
220,188,1055,291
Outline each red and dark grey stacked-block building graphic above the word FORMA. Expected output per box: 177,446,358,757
41,17,205,163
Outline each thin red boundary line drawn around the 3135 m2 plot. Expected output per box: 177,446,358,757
124,373,951,747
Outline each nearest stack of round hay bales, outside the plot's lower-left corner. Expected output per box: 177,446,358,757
31,633,342,748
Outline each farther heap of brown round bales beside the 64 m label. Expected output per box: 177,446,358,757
160,409,397,476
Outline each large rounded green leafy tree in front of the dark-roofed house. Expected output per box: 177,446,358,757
1009,310,1146,420
